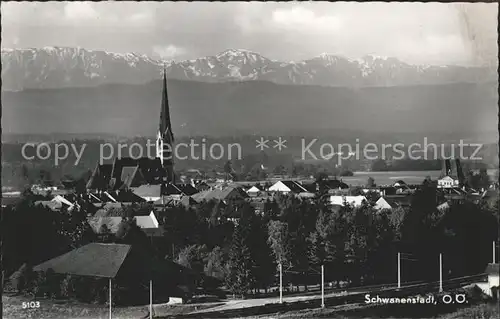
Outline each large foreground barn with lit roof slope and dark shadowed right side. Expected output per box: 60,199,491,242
33,243,200,311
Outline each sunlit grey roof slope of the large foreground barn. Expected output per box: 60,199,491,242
33,243,131,278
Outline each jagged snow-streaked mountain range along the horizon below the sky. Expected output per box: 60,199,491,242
2,47,497,91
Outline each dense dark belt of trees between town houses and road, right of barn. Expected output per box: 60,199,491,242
160,187,498,295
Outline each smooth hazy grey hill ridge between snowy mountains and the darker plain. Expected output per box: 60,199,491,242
2,80,498,136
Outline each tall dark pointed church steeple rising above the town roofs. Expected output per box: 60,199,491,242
156,67,174,183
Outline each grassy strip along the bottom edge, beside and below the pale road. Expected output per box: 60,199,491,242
3,295,500,319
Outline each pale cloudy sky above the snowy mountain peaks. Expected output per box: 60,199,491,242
1,2,498,64
